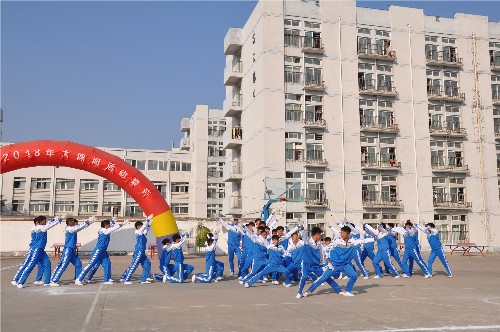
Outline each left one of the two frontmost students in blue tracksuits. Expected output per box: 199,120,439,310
296,227,335,299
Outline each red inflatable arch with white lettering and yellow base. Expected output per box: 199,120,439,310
0,141,179,242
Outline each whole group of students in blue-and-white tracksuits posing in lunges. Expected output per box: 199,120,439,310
12,215,453,298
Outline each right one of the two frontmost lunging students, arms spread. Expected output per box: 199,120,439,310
304,226,374,296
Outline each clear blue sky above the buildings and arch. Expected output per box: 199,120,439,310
1,1,500,149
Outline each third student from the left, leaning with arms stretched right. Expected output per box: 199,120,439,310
75,220,123,286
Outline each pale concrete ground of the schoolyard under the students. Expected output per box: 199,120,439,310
0,254,500,332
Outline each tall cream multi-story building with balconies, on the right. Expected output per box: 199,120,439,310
223,0,500,246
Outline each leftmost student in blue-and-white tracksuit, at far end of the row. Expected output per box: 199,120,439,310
17,216,62,288
